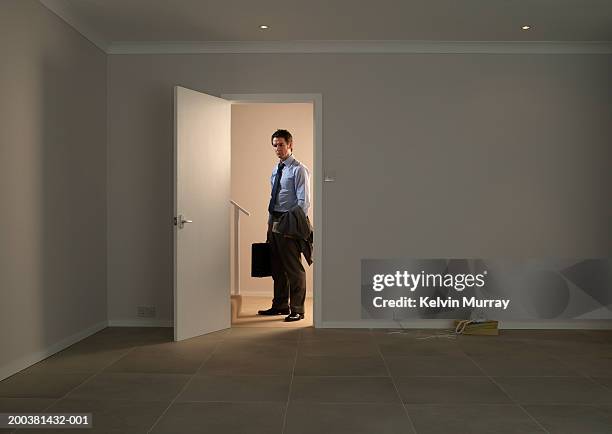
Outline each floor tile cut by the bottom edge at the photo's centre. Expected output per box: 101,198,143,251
284,402,415,434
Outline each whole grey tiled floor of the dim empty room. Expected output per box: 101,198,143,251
0,327,612,434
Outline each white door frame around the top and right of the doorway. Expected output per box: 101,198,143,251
221,93,323,328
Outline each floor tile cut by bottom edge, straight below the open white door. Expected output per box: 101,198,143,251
151,402,284,434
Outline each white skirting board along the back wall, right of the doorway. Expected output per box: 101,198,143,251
317,319,612,330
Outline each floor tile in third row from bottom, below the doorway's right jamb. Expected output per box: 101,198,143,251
295,355,389,377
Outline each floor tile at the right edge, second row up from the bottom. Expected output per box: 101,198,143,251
495,377,612,404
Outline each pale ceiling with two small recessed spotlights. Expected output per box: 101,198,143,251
40,0,612,53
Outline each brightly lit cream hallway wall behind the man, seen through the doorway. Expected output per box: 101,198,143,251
231,103,315,298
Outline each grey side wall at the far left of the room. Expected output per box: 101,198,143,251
0,0,107,379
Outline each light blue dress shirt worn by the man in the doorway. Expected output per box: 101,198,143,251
270,155,310,215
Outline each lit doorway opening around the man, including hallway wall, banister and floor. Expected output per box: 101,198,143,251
230,102,317,328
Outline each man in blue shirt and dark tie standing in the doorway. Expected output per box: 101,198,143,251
258,130,310,322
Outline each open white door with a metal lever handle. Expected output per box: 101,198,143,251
174,86,231,341
